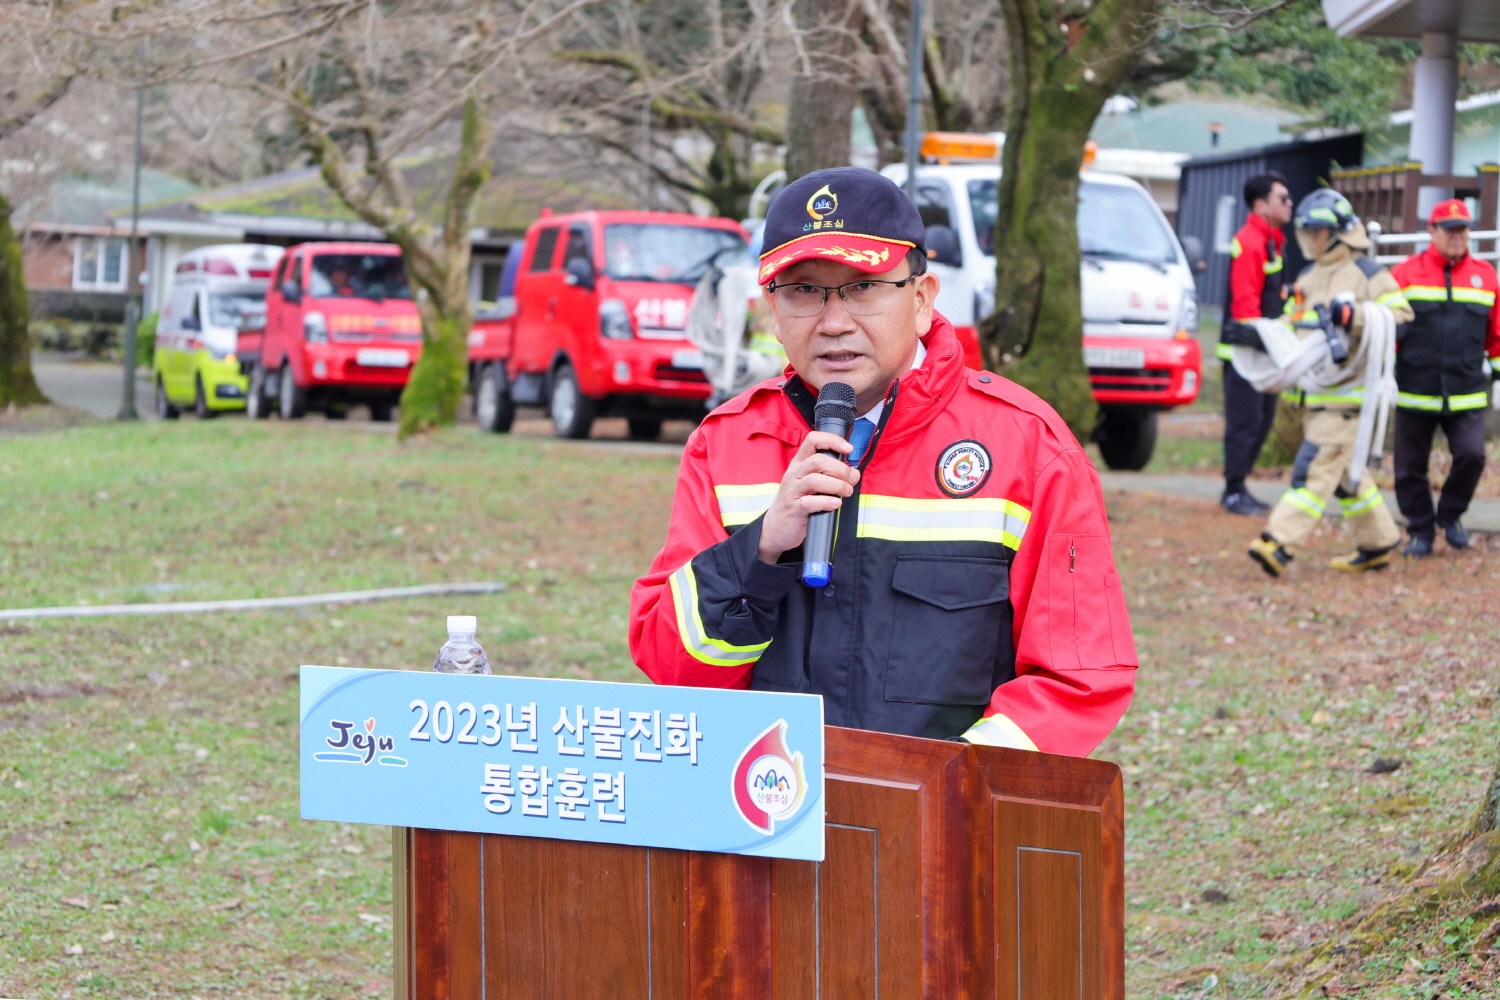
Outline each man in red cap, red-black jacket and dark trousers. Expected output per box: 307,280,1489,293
1392,198,1500,559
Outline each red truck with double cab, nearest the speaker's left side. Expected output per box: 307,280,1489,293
470,211,747,439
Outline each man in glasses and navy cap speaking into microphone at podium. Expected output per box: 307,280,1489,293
630,168,1137,756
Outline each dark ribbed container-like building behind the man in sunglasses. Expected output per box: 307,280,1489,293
1178,132,1365,306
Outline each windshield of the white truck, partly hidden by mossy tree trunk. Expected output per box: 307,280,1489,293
969,180,1178,264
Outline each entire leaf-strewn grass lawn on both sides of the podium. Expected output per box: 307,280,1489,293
0,420,1500,1000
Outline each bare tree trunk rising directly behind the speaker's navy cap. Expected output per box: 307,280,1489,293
786,0,861,183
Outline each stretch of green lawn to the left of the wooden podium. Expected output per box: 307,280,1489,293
0,420,677,999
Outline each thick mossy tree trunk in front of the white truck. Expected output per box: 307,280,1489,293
981,0,1161,441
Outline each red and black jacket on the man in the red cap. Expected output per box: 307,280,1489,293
1391,246,1500,412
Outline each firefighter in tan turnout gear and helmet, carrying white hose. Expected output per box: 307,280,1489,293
1250,187,1413,576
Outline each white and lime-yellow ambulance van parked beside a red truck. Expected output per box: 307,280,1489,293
152,243,282,420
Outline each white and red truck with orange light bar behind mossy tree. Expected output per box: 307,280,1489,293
881,143,1203,469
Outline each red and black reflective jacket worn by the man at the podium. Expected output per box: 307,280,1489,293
630,316,1137,756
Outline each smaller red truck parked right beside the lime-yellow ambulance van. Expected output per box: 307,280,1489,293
248,243,422,420
